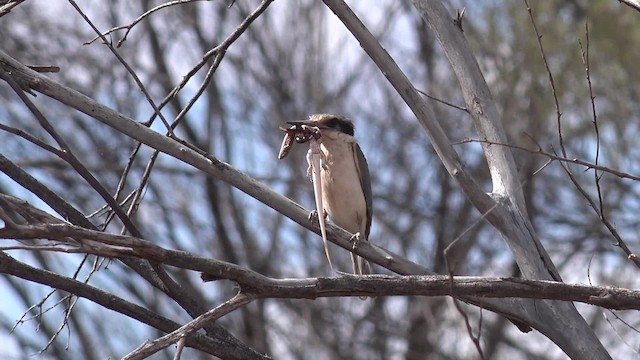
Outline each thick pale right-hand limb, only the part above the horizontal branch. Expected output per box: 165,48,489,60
414,0,561,281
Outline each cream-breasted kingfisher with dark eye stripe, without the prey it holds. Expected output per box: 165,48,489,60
287,114,373,275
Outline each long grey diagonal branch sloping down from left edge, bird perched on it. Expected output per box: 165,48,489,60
0,50,410,274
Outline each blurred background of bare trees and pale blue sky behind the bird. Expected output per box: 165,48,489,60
0,0,640,359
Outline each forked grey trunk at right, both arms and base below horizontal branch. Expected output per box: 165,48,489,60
324,0,611,359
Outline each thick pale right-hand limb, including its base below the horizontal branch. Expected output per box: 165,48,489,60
413,0,611,359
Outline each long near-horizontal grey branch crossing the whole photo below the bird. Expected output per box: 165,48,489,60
0,219,640,310
